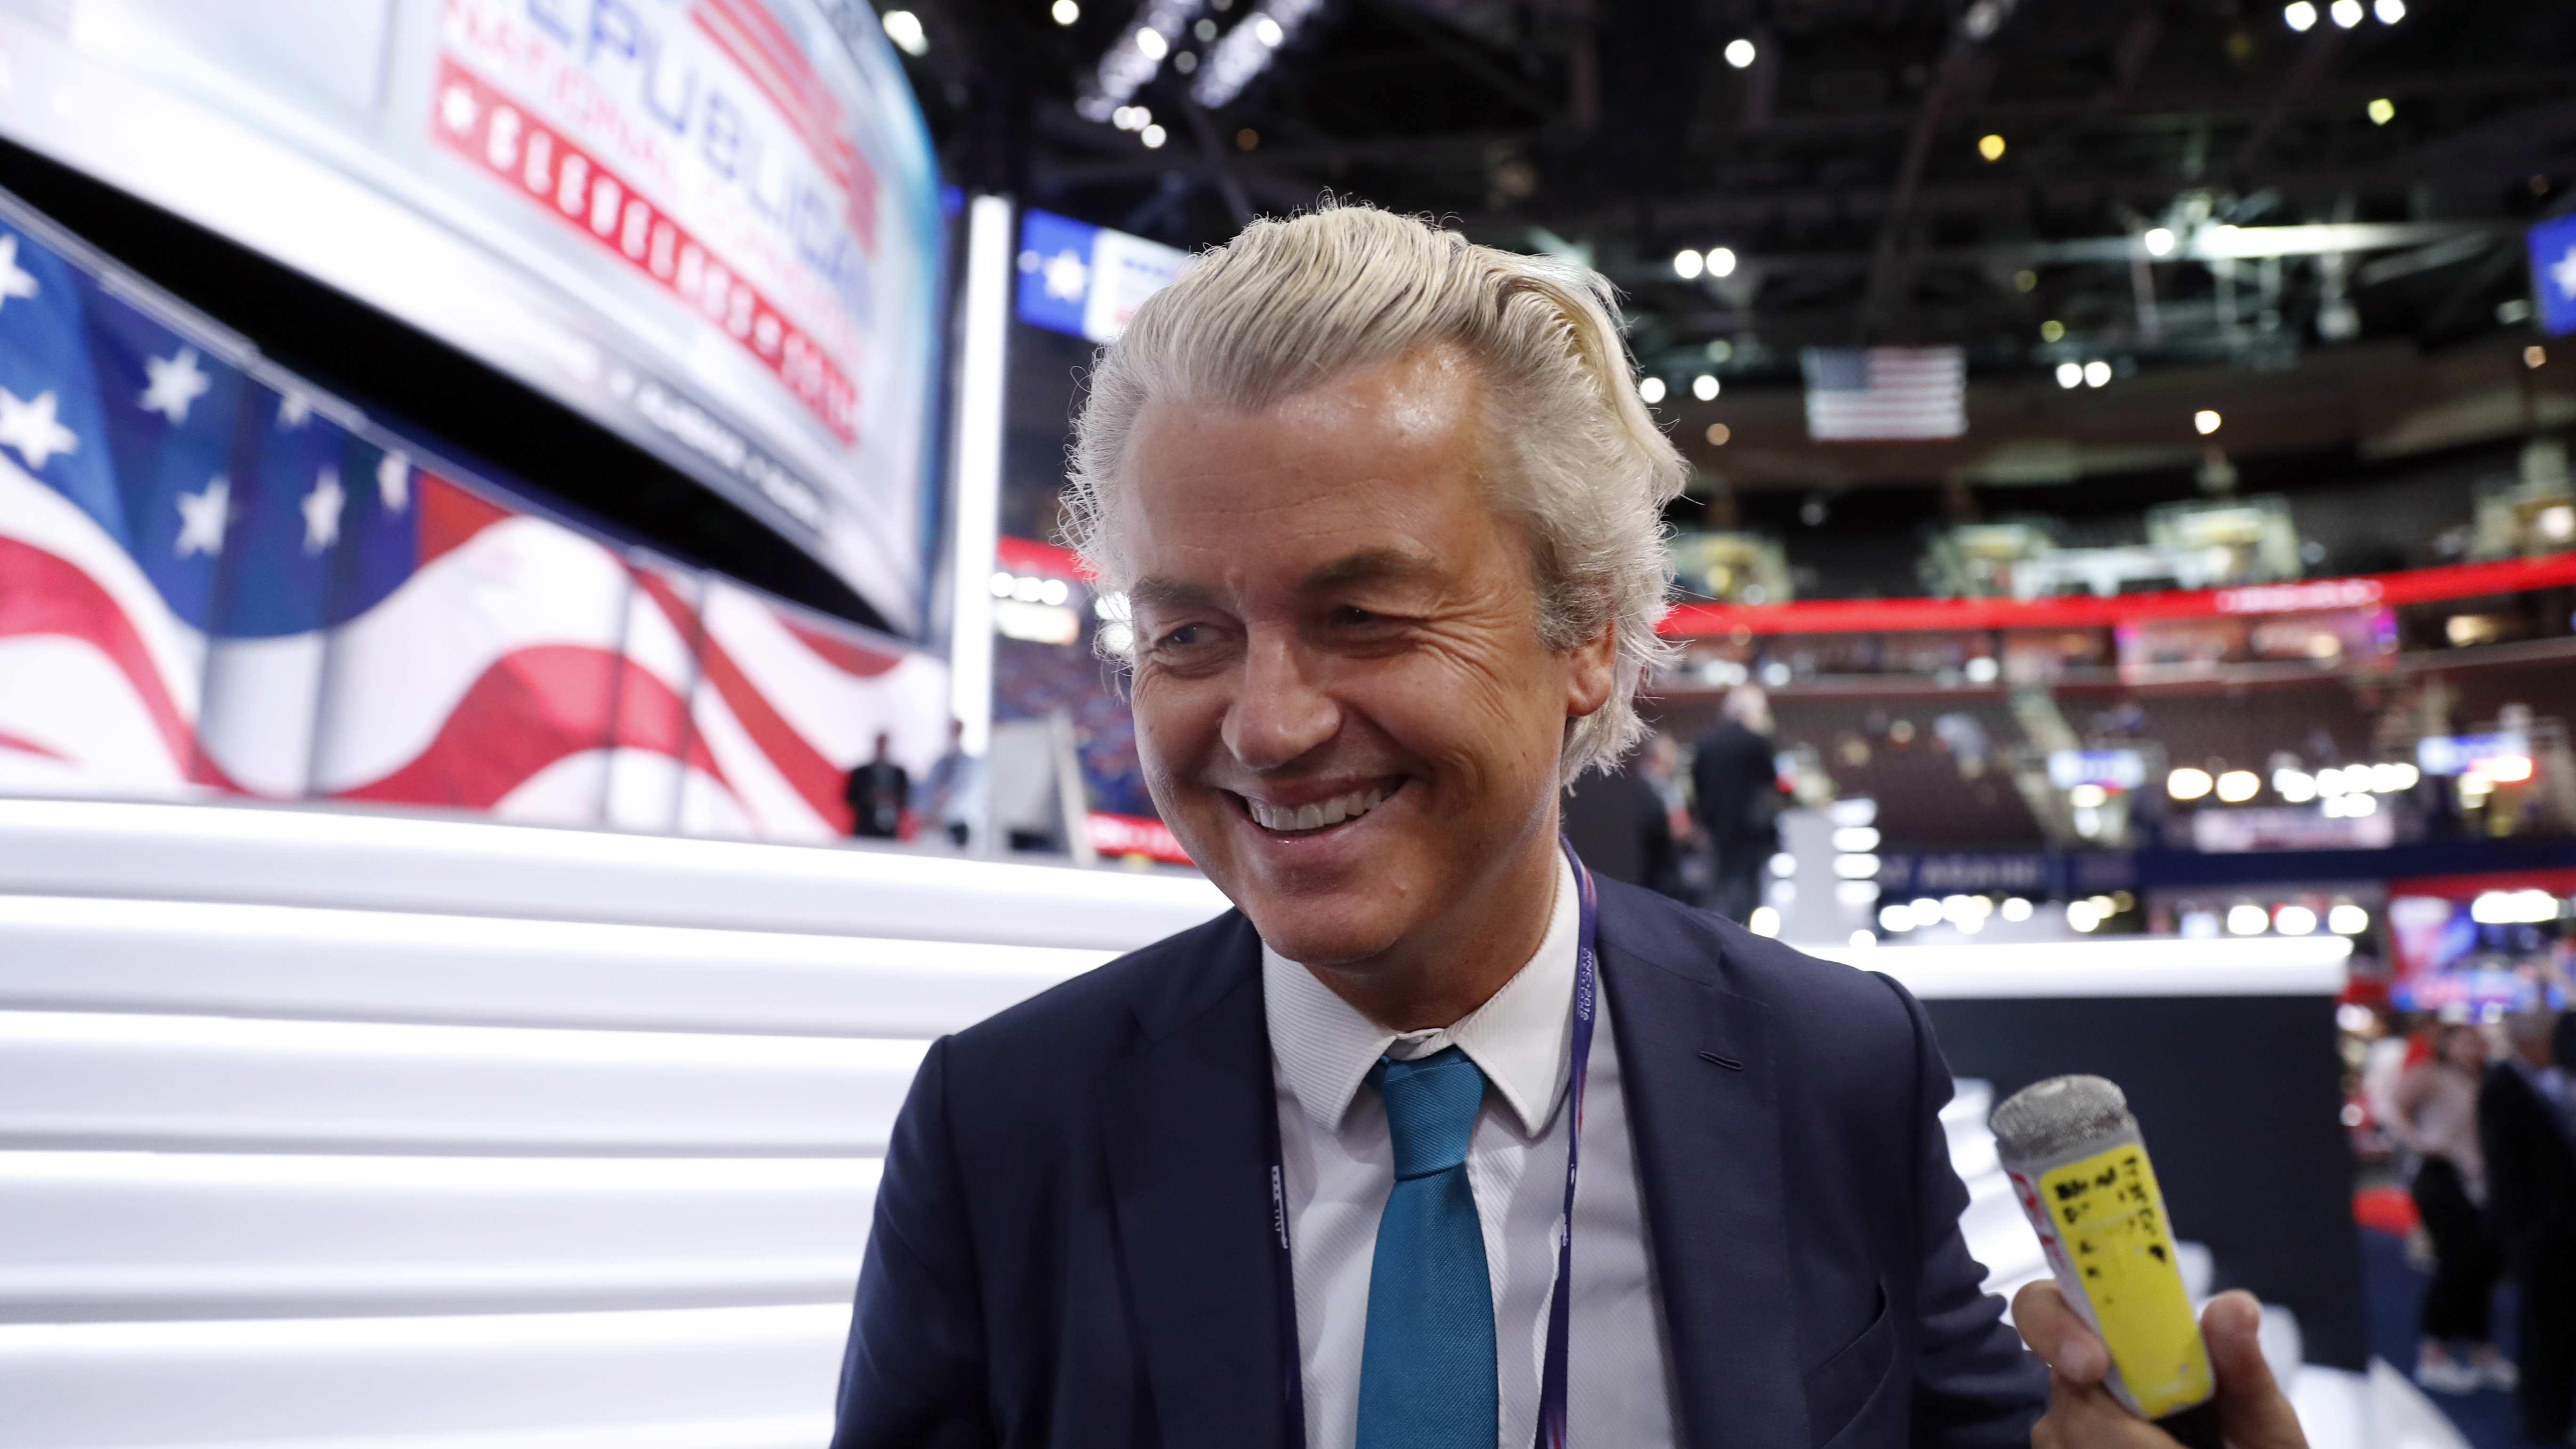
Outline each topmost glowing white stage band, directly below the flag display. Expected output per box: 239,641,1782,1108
0,799,1226,951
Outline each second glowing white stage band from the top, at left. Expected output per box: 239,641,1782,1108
0,894,1110,1037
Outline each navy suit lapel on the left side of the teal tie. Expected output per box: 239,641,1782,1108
1103,923,1286,1449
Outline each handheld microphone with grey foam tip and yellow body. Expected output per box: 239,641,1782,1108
1988,1075,2223,1449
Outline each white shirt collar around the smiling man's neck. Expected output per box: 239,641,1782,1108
1262,851,1582,1137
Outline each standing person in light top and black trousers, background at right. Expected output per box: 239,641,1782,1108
2385,1026,2514,1395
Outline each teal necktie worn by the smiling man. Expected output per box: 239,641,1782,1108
1360,1047,1499,1449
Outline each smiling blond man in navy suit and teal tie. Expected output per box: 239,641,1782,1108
835,206,2298,1449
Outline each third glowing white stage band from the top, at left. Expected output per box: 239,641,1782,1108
0,1011,925,1155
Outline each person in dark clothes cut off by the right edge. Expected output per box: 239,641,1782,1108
2478,1011,2576,1444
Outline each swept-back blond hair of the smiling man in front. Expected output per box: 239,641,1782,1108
1066,204,1685,781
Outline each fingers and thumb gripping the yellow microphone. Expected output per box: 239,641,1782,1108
2012,1279,2308,1449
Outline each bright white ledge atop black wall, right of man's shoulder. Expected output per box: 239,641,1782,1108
1803,936,2352,1000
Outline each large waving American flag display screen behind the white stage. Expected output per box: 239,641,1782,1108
0,192,945,838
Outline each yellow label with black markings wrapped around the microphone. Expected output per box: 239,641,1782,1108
2012,1140,2215,1418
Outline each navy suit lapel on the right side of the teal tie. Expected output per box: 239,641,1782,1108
1600,892,1808,1449
